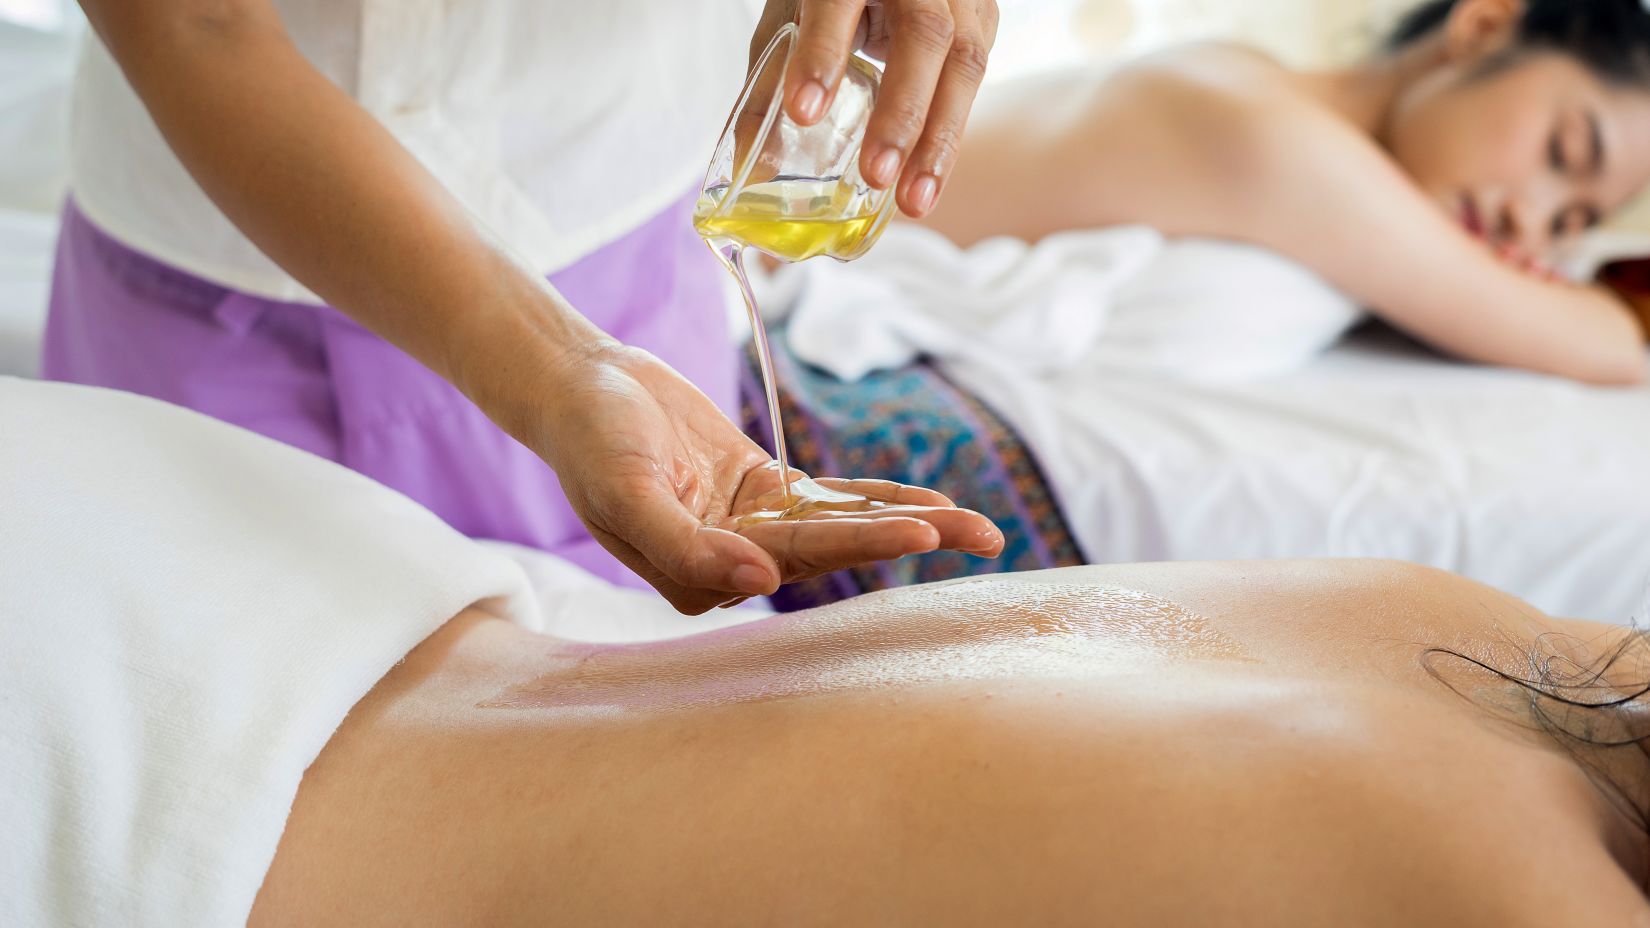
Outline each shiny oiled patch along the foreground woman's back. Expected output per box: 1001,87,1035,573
482,580,1247,710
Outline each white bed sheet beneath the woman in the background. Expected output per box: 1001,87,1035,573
945,332,1650,623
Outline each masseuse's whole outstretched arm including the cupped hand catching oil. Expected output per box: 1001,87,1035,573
81,0,1002,613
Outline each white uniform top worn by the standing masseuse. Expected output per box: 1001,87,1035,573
71,0,757,302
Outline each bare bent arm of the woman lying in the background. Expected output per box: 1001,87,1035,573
1227,88,1645,385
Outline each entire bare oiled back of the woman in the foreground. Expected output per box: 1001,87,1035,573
254,561,1647,925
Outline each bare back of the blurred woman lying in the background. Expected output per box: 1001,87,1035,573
927,45,1346,244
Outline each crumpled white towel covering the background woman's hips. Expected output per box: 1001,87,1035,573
785,225,1361,380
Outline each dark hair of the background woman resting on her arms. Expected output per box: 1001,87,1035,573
1386,0,1650,84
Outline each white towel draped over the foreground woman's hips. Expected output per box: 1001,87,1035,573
0,378,538,928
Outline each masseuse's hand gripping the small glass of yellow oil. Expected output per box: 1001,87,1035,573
751,0,997,216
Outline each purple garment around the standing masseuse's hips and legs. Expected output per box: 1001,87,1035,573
45,191,738,586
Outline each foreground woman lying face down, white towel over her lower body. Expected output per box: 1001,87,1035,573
0,373,1650,925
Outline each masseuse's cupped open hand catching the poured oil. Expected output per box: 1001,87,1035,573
526,343,1003,614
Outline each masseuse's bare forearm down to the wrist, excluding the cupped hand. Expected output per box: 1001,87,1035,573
83,0,606,428
